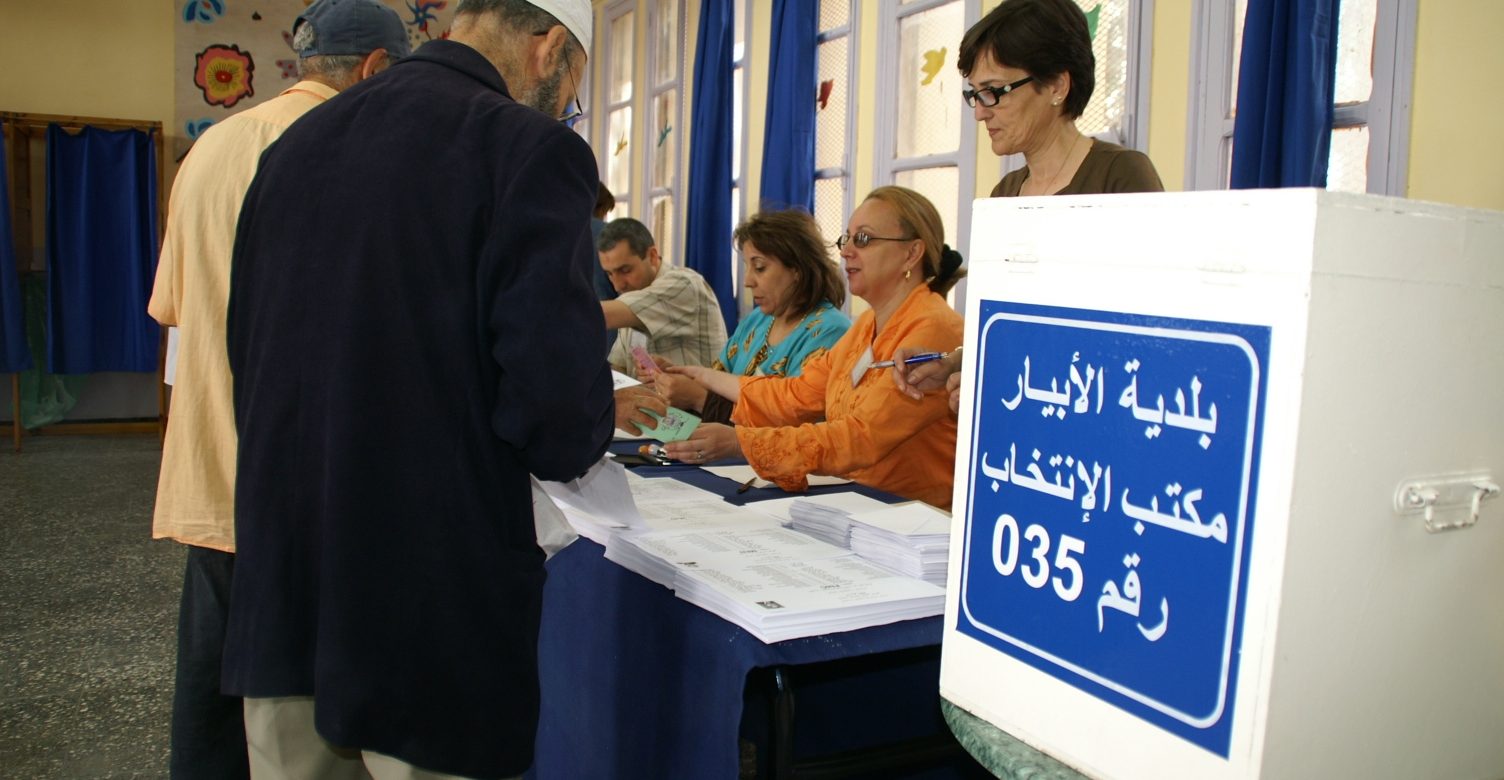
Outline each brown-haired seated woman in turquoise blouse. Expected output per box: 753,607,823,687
657,210,851,422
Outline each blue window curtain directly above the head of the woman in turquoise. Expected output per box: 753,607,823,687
761,0,820,212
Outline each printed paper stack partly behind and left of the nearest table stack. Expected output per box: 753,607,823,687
606,529,850,588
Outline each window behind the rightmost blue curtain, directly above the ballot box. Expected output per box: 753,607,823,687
1185,0,1415,195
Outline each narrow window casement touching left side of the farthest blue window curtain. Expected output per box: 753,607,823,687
644,0,684,265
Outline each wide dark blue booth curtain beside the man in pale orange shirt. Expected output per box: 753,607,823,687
47,125,161,374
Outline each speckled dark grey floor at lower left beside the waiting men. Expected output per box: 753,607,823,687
0,436,183,778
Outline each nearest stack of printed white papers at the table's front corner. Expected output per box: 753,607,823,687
674,553,945,642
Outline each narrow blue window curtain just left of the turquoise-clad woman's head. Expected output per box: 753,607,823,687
684,0,737,332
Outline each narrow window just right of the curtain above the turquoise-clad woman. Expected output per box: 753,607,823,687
814,0,859,250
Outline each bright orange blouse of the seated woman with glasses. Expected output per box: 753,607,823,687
731,286,963,509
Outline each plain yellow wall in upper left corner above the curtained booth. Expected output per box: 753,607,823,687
0,0,176,134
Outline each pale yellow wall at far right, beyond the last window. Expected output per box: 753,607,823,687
1408,0,1504,210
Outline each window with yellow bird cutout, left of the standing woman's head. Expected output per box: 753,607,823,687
872,0,978,287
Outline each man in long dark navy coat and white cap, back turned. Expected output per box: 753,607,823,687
223,0,614,777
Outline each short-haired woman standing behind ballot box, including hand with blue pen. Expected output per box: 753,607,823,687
892,0,1164,410
